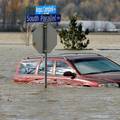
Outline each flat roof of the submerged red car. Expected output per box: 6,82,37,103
24,53,103,61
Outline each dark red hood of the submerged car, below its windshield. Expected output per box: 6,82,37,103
84,72,120,83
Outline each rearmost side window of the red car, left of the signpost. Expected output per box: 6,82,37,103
19,61,38,74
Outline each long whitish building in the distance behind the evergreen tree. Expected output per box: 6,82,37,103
56,20,117,32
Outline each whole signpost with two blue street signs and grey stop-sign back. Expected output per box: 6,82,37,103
26,3,61,88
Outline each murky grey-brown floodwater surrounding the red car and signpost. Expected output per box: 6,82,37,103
0,45,120,120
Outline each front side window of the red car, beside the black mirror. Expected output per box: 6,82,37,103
55,61,75,75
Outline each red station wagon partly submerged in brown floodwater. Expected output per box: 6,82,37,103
13,53,120,87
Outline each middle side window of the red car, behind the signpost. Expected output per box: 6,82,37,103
38,60,54,74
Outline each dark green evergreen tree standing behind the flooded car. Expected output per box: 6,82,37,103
59,16,89,50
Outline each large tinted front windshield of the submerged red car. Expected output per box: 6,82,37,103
73,58,120,74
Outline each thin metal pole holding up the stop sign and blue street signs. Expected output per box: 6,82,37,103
43,23,47,88
